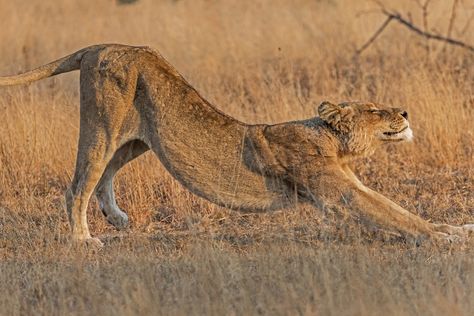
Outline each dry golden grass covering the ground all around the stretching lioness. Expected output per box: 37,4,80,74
0,0,474,315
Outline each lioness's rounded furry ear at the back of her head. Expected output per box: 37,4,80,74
318,101,354,132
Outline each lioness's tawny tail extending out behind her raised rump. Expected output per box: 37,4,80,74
0,46,96,86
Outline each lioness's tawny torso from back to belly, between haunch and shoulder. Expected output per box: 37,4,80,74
135,68,292,210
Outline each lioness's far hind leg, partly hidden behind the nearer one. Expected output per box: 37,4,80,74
95,140,149,229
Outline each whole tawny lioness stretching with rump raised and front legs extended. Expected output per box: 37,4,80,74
0,45,472,245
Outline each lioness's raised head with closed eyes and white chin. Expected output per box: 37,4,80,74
318,101,413,153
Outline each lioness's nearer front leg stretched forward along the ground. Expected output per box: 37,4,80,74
306,169,463,239
